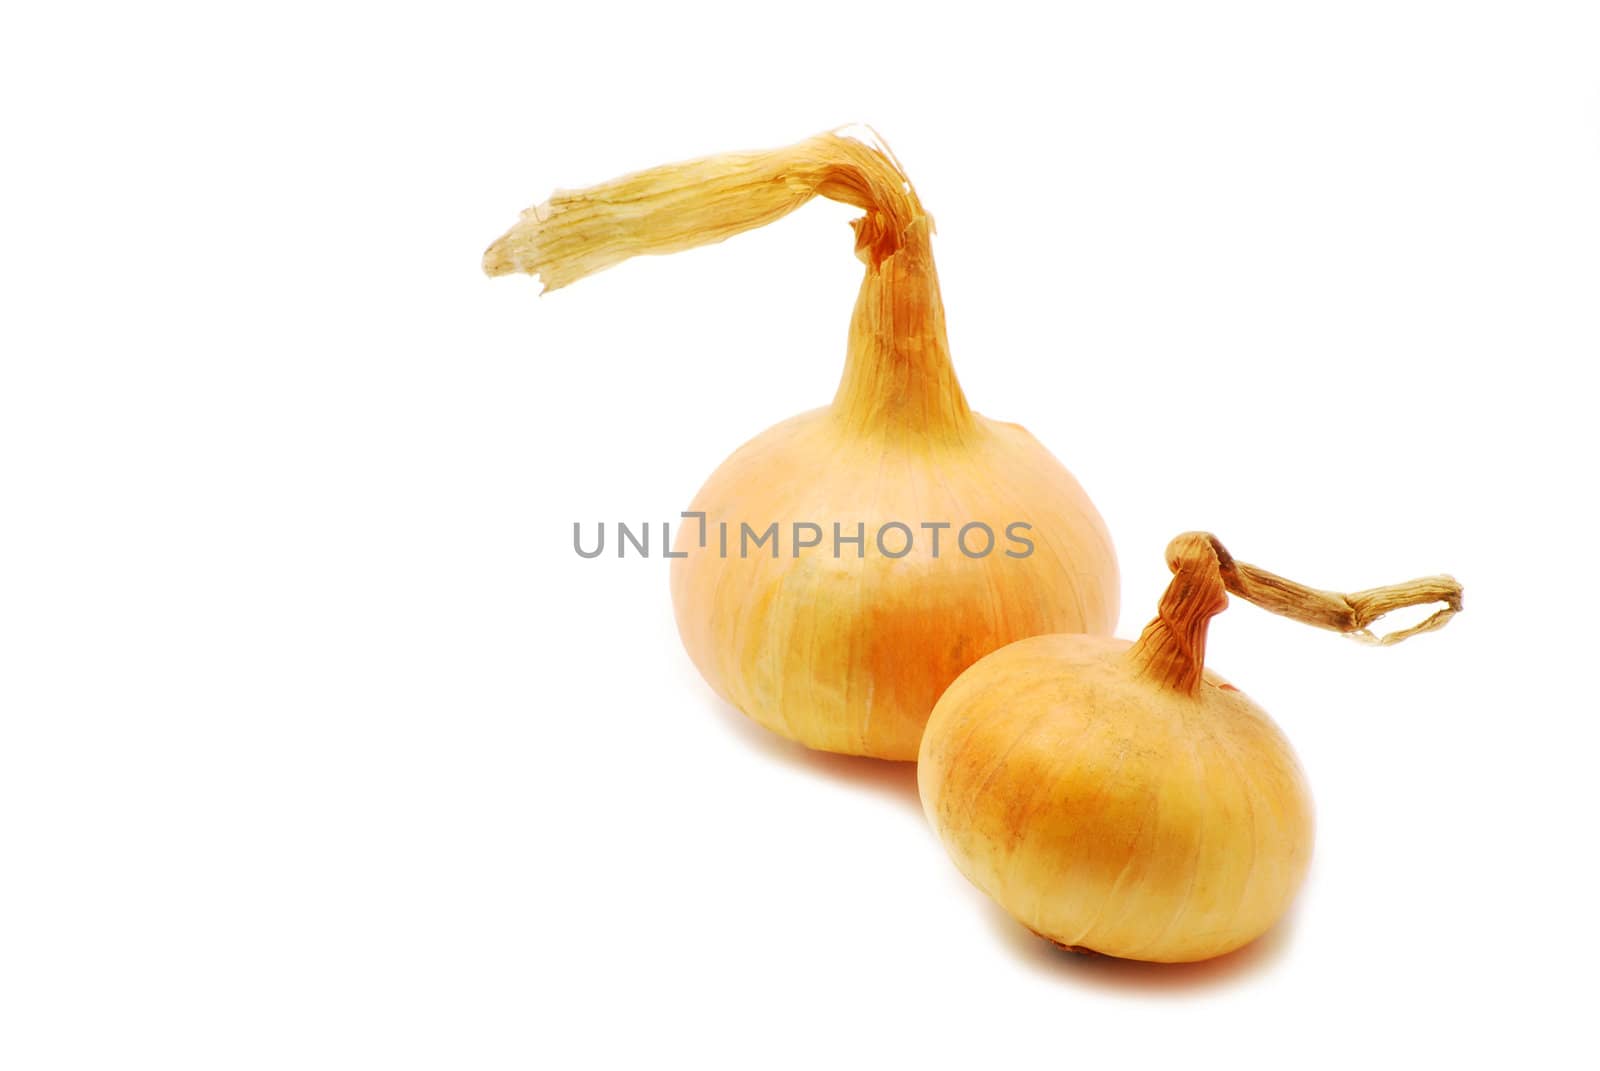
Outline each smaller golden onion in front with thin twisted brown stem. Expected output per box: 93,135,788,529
917,533,1461,962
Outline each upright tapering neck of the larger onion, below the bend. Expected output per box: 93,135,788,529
834,215,973,440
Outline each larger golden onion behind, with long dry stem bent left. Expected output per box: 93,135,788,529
483,133,1117,760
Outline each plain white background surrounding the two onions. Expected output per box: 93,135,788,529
0,0,1600,1071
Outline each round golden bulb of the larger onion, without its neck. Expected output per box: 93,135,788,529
672,408,1117,760
